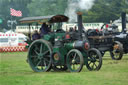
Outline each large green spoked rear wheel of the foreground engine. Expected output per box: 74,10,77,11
28,39,52,72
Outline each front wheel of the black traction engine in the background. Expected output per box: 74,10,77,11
110,41,123,60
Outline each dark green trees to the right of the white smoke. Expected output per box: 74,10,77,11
84,0,128,22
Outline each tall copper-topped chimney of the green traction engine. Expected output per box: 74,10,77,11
77,12,83,40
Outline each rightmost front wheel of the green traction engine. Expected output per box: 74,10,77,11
86,48,102,71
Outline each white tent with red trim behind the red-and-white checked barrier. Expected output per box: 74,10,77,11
0,30,27,47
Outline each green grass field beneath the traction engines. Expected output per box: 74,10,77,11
0,52,128,85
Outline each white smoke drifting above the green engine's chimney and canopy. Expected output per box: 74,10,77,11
65,0,95,22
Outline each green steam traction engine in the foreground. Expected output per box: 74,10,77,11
21,13,102,72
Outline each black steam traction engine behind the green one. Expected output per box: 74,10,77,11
86,13,128,60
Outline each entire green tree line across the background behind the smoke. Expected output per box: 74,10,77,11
0,0,128,29
